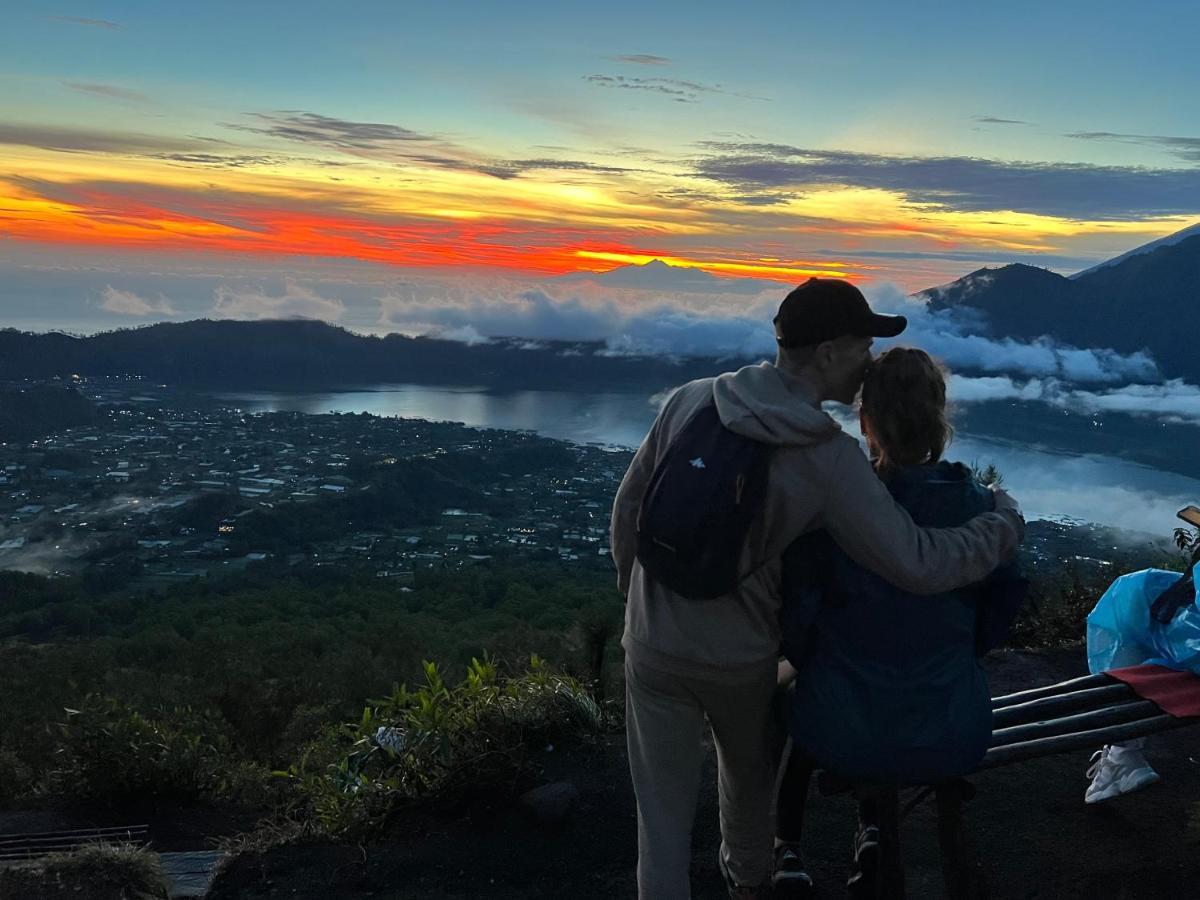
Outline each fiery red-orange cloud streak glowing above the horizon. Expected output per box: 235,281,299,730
0,182,864,280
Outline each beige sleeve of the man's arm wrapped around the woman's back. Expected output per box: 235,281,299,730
820,442,1025,594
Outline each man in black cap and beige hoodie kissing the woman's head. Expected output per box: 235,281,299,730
612,278,1024,900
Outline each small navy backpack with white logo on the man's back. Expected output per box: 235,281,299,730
637,403,770,600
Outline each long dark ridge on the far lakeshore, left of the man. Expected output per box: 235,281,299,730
0,319,722,390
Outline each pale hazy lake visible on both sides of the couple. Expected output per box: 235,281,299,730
216,384,1200,535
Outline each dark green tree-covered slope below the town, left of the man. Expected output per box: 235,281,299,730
0,563,622,799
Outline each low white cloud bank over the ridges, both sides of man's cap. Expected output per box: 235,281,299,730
379,282,1158,384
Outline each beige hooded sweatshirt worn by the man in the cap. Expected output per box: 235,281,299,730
612,362,1024,678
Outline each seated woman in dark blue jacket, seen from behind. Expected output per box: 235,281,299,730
775,348,1026,896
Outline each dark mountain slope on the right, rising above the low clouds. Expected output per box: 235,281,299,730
922,234,1200,378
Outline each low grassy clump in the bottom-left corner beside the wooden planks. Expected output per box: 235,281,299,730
0,844,170,900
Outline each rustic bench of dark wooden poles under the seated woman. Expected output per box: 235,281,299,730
817,666,1200,900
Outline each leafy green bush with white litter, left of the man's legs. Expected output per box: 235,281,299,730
278,656,607,838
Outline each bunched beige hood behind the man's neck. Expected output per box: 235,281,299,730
713,362,841,446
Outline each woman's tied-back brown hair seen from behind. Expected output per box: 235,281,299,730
862,347,954,474
